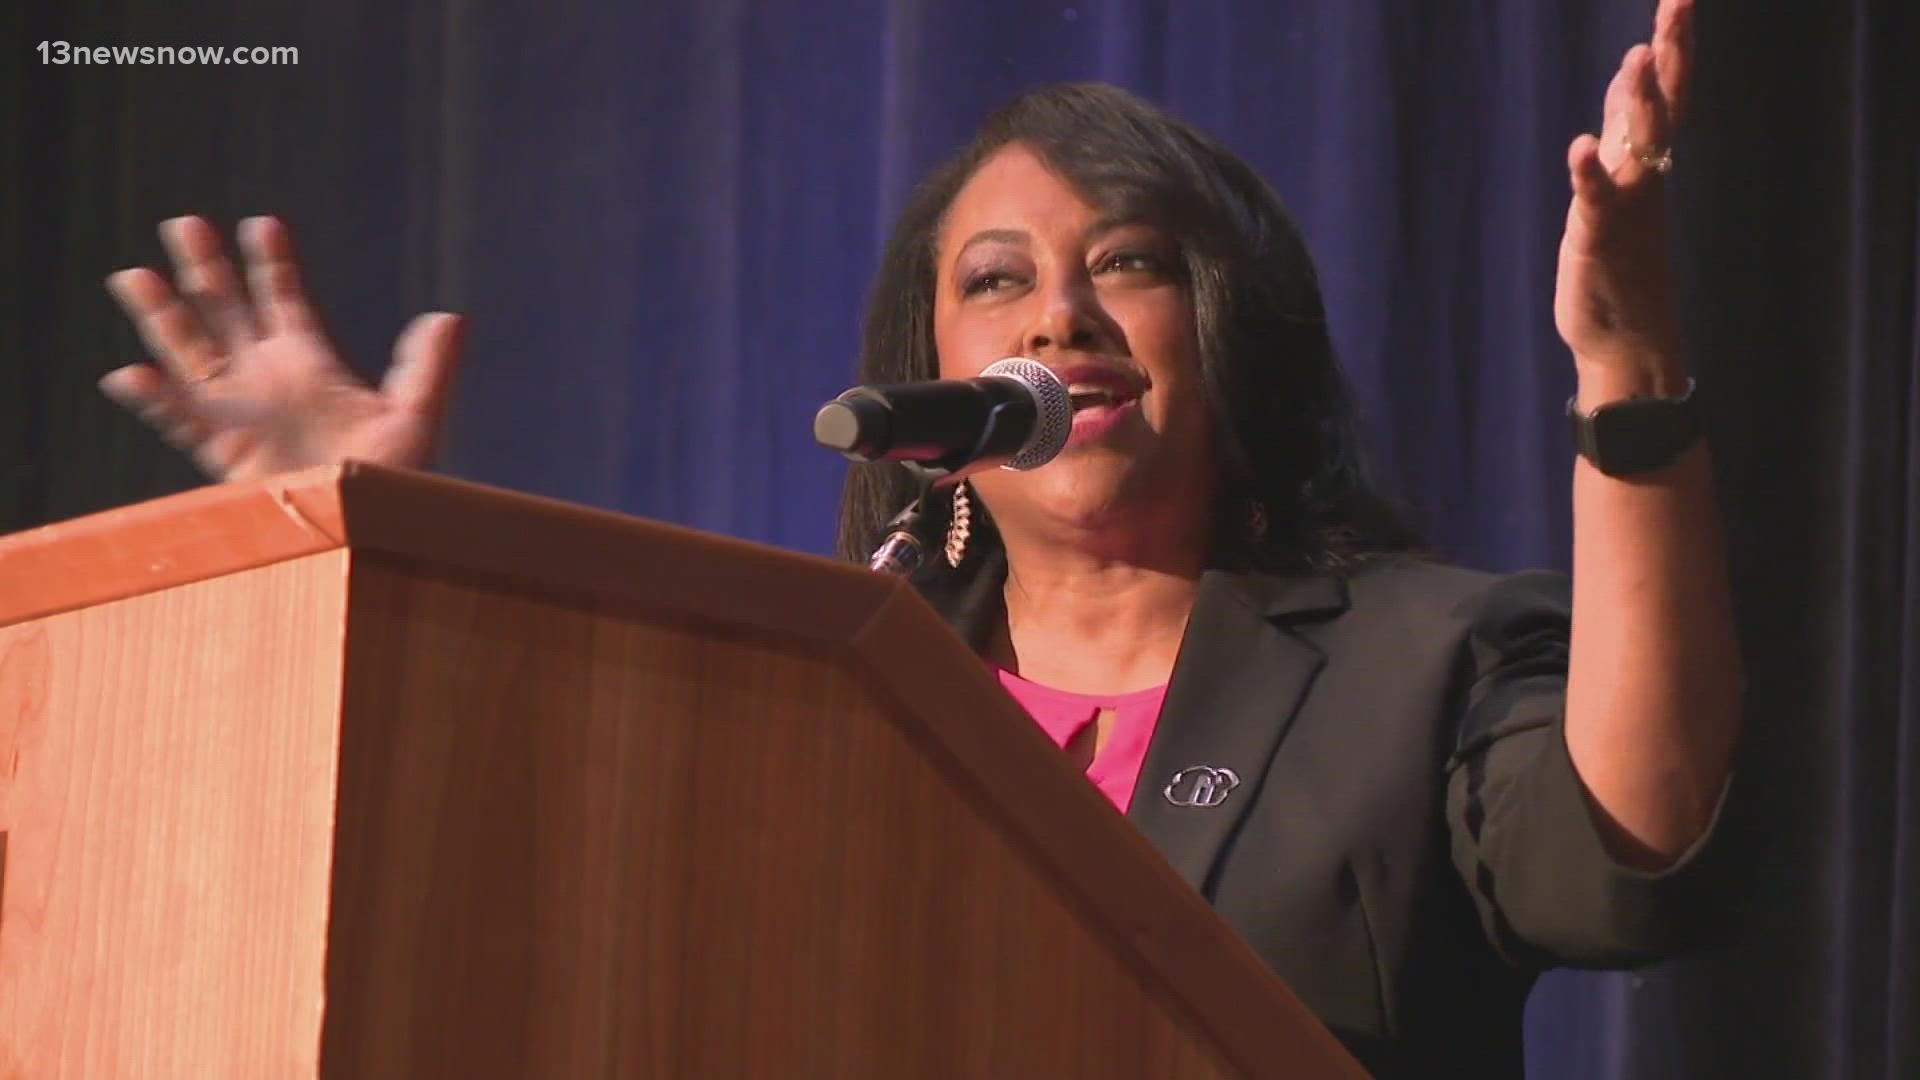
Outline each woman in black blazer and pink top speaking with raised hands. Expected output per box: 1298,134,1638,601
93,0,1740,1076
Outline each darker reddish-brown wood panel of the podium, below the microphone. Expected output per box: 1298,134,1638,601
324,559,1229,1078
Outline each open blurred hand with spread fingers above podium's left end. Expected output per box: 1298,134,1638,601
100,217,465,480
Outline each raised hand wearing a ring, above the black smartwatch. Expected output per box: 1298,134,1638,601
1553,0,1693,386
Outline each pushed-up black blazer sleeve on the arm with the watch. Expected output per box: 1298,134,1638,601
1446,573,1726,969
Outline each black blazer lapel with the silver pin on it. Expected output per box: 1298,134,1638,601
1127,571,1348,896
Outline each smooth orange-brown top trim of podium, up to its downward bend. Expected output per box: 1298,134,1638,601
0,461,906,640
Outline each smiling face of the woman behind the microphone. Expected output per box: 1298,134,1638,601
933,144,1213,530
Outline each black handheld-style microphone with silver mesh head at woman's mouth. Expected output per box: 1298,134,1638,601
814,356,1073,473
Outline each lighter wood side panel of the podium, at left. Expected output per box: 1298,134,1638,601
0,550,348,1078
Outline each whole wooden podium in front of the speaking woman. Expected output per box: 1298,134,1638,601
0,463,1361,1080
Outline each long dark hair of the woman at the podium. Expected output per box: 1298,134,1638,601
839,83,1417,588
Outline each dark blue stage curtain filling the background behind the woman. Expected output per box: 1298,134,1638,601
0,0,1920,1078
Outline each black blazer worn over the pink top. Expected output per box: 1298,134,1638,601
931,557,1713,1078
